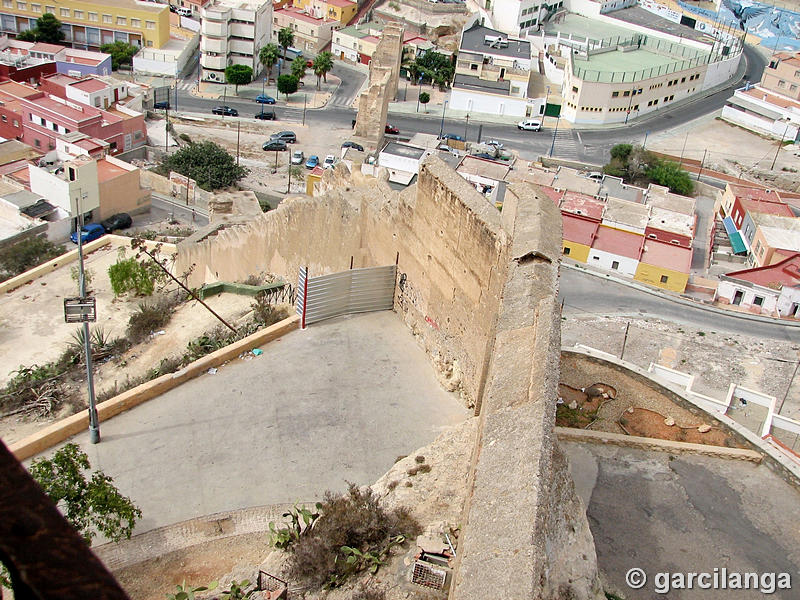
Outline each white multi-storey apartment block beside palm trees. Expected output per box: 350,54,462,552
200,0,272,83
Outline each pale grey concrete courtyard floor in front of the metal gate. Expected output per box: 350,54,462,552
39,312,470,533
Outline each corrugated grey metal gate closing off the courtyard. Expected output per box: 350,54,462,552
296,265,397,327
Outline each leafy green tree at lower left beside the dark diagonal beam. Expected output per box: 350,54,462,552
29,444,142,543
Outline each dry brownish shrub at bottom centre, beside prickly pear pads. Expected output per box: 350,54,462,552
288,483,422,587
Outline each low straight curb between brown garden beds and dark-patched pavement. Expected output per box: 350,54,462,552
556,427,764,464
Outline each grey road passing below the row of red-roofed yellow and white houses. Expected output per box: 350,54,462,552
559,268,800,343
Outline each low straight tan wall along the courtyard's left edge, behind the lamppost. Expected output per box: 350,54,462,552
9,315,299,461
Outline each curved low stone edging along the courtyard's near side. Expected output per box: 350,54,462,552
92,504,294,571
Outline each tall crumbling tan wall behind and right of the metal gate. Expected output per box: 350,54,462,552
175,157,508,405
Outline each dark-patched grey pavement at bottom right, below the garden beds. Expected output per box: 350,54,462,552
562,442,800,600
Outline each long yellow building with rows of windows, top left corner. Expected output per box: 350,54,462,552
0,0,169,50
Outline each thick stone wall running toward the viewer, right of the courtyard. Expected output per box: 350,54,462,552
450,184,603,600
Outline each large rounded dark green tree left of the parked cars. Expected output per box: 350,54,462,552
158,141,250,191
